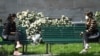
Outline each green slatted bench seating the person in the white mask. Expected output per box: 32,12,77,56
41,26,85,53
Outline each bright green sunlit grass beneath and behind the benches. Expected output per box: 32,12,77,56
0,43,100,56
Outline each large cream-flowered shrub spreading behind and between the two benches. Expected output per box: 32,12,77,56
17,10,71,37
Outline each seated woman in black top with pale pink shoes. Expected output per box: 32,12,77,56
2,14,22,55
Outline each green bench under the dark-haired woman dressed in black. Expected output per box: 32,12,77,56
0,26,31,53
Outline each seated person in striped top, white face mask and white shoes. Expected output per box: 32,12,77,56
80,12,99,53
